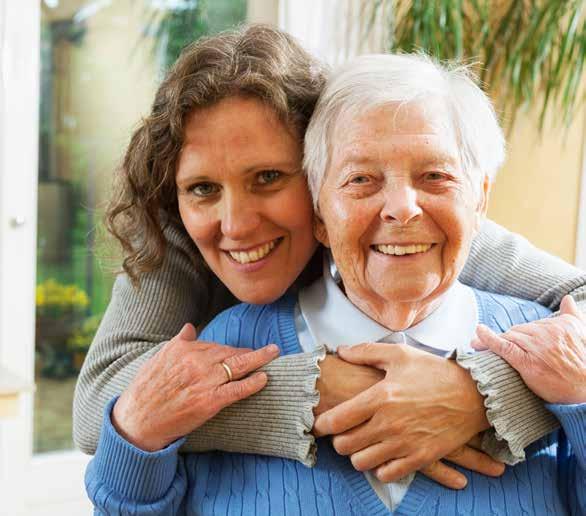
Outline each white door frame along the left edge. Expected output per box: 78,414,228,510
0,0,89,516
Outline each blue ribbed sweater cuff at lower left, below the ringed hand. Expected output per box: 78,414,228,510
88,396,185,502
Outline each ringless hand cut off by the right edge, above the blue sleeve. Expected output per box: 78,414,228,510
472,296,586,403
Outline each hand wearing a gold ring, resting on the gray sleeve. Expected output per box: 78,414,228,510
112,324,279,451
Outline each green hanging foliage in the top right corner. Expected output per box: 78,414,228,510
367,0,586,124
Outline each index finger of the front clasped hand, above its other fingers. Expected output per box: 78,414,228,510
313,384,382,437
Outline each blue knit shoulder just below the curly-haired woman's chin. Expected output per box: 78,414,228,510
199,295,297,349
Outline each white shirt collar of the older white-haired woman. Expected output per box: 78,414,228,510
299,258,478,351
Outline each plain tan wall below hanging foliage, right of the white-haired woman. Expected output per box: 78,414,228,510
488,101,586,262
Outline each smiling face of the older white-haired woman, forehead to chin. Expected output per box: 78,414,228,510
316,99,488,324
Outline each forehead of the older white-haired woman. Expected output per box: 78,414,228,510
330,98,458,164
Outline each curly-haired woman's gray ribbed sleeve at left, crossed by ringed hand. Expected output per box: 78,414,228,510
73,224,319,465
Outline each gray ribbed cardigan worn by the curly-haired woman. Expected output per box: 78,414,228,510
73,221,586,465
